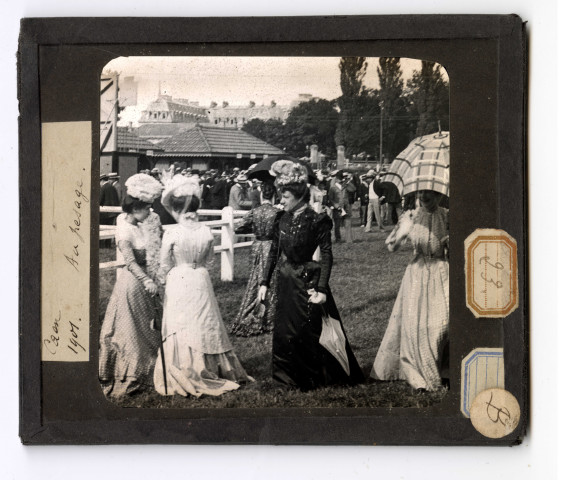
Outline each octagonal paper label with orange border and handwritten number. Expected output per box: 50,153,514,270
464,229,519,318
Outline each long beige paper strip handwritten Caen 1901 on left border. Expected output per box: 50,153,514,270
41,122,92,362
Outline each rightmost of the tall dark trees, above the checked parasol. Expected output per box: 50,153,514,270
408,61,449,137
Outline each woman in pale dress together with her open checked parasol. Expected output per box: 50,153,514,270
371,133,449,391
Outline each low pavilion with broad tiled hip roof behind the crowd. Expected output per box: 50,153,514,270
153,124,284,170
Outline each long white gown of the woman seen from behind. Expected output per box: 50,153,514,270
154,221,253,397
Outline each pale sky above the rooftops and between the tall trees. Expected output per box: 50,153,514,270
100,56,442,123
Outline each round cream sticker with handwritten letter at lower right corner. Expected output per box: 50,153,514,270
470,388,521,438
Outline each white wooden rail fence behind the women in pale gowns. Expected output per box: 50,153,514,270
99,207,254,282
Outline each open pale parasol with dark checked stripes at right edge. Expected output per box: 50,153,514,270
381,132,450,196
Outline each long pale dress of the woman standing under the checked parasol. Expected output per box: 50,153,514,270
371,207,449,390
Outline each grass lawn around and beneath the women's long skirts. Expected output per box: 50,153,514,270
100,212,446,408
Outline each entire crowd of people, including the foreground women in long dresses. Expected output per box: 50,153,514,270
99,160,449,397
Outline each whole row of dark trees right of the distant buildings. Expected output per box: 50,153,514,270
243,57,449,161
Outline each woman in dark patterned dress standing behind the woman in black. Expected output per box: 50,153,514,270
230,183,281,337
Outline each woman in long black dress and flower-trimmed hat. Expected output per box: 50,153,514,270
258,160,363,390
